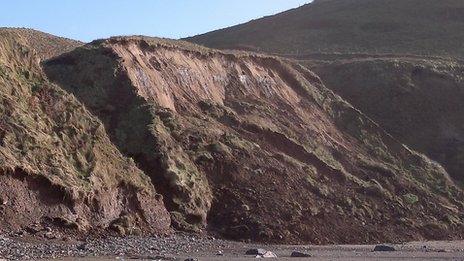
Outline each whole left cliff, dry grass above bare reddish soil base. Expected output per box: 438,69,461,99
0,30,170,234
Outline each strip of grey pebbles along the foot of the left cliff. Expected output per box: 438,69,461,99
0,232,229,260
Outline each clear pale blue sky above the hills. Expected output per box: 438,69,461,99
0,0,311,42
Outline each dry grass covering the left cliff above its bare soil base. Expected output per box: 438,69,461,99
0,30,153,193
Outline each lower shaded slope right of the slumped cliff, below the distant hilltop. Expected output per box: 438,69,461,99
308,58,464,185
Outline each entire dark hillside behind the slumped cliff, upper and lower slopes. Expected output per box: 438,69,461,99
187,0,464,187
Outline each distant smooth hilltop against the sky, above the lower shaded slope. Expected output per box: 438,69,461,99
186,0,464,57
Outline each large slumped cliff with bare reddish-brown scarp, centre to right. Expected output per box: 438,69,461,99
44,37,464,243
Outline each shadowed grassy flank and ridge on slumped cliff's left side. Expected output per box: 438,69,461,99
45,40,212,231
